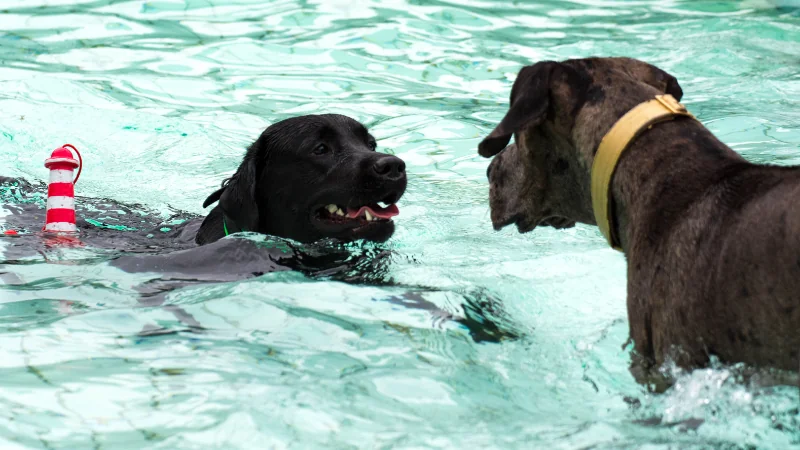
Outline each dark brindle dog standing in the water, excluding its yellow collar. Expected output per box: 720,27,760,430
479,58,800,381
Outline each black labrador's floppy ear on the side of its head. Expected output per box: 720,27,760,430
216,152,258,231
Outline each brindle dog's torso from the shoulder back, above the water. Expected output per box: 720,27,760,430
628,157,800,370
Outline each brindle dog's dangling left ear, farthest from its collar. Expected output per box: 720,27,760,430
478,61,558,158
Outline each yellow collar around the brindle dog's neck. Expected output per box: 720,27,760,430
592,94,694,251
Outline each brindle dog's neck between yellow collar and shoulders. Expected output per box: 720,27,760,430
592,118,746,254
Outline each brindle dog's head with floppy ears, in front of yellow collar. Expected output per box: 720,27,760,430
478,58,683,233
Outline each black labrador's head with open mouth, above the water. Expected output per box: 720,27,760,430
198,114,406,243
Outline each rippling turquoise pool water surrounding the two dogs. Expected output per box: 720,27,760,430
0,0,800,449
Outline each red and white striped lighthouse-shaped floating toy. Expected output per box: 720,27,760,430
42,144,83,233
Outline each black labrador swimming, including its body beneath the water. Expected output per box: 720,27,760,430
0,114,512,341
